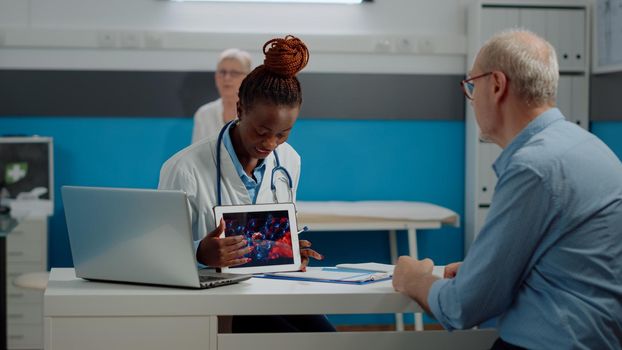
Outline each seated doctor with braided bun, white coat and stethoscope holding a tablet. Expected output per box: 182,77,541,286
158,36,334,332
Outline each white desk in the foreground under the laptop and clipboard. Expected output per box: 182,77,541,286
44,269,497,350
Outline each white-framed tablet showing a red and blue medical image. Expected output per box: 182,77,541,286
214,203,300,273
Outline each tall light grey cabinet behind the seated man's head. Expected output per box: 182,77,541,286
464,0,590,253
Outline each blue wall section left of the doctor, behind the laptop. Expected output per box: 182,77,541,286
0,117,192,267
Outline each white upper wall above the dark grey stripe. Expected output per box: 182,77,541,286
0,0,468,73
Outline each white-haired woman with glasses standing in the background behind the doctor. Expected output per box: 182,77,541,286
192,49,251,143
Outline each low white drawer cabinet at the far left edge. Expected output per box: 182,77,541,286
6,217,48,349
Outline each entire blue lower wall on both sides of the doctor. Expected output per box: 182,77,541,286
0,117,464,266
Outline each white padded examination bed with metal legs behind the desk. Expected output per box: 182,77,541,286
296,201,460,331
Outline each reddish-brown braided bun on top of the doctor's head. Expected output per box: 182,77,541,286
263,35,309,78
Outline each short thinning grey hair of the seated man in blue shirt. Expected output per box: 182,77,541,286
477,28,559,107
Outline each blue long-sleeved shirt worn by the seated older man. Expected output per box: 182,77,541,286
428,108,622,349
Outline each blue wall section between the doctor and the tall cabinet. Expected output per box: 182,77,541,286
290,120,464,265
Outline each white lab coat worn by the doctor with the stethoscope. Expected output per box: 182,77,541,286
158,137,300,241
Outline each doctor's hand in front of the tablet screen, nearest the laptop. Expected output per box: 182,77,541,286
197,219,253,267
